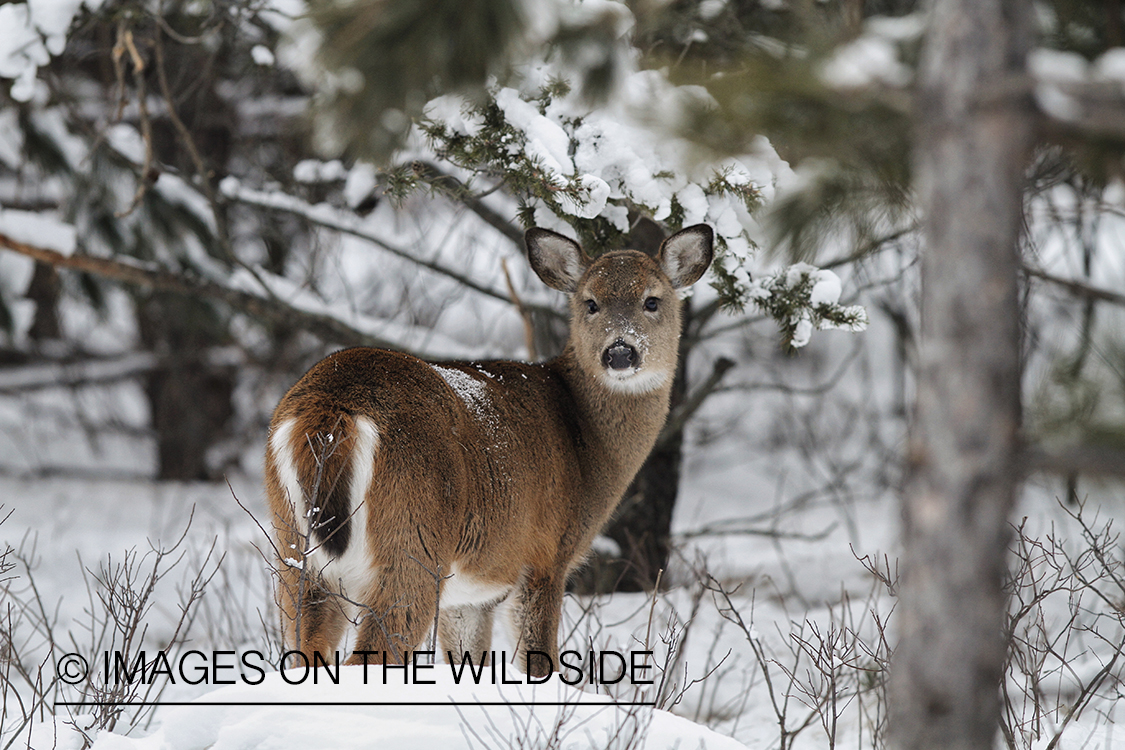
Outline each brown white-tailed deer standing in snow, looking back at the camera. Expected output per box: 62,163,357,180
266,224,713,678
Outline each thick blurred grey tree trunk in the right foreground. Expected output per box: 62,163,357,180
891,0,1033,750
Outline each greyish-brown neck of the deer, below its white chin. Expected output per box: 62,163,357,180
550,346,672,493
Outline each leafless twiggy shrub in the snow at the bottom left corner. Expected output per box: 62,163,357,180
0,518,223,750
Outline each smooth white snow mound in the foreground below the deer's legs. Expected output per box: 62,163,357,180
81,663,746,750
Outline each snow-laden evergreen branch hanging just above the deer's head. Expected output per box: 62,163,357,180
409,55,867,347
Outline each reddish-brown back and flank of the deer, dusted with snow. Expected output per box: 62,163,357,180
268,349,586,579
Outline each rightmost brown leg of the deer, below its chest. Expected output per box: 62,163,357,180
512,573,566,677
